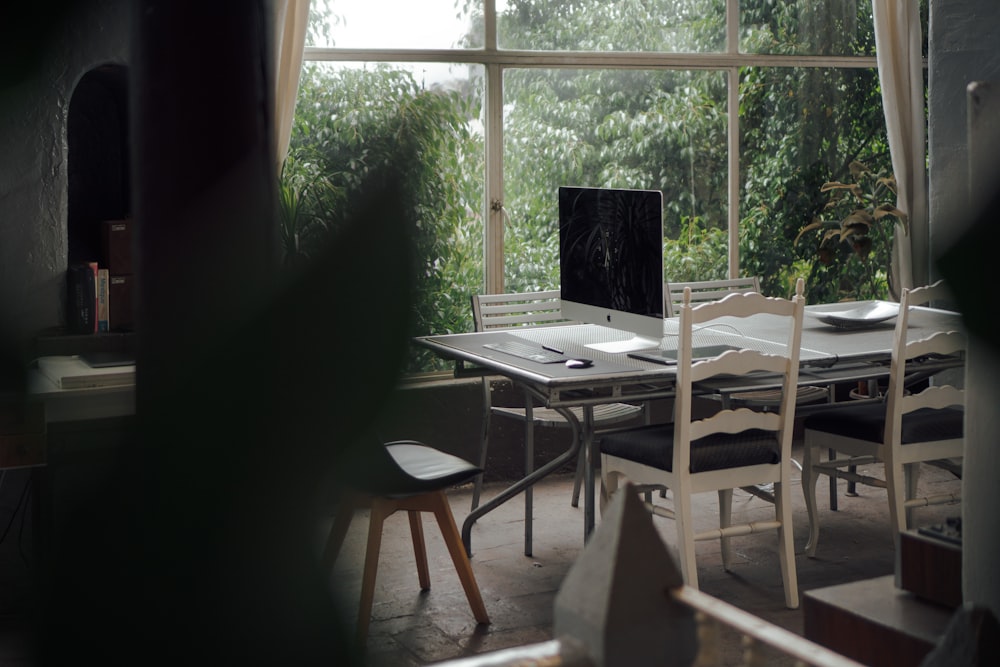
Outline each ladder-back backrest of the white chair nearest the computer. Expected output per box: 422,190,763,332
674,279,805,478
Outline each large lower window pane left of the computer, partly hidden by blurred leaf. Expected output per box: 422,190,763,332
283,63,484,371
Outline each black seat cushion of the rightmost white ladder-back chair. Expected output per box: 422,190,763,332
803,403,965,445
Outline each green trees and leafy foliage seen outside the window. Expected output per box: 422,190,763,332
281,0,904,371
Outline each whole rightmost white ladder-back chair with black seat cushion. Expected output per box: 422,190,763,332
802,282,965,557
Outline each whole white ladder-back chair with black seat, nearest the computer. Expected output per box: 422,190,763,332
600,280,804,609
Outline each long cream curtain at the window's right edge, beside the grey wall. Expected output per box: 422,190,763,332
872,0,929,296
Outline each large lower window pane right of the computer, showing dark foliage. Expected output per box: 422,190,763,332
740,68,896,303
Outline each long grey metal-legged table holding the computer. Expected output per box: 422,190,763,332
416,304,962,553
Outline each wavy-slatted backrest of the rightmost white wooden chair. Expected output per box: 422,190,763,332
884,281,966,444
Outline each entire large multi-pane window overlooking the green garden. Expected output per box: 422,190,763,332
284,0,916,371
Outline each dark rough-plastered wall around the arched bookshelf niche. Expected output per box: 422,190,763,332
0,0,131,339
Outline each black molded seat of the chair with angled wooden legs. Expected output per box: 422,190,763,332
358,440,482,497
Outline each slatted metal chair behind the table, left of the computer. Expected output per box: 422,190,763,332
472,290,644,556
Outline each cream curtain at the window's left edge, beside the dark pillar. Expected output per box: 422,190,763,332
273,0,309,174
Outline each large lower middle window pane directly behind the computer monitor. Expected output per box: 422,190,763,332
504,69,727,291
